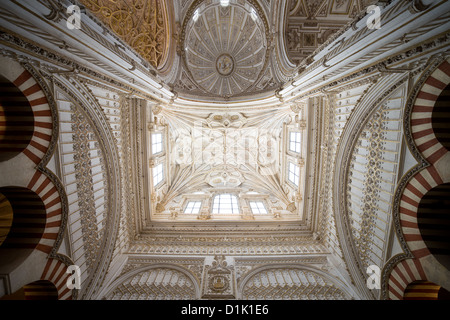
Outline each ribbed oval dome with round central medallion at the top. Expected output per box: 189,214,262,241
185,1,266,97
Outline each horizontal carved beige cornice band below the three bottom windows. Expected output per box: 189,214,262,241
128,231,328,256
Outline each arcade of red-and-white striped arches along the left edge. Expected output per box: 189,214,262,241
0,57,72,300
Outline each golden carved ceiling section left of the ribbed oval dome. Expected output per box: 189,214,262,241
82,0,171,68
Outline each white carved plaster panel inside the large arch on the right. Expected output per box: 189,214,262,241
347,88,406,276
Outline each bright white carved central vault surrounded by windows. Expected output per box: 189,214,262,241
151,107,298,222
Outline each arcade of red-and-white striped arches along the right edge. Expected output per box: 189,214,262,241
388,59,450,300
